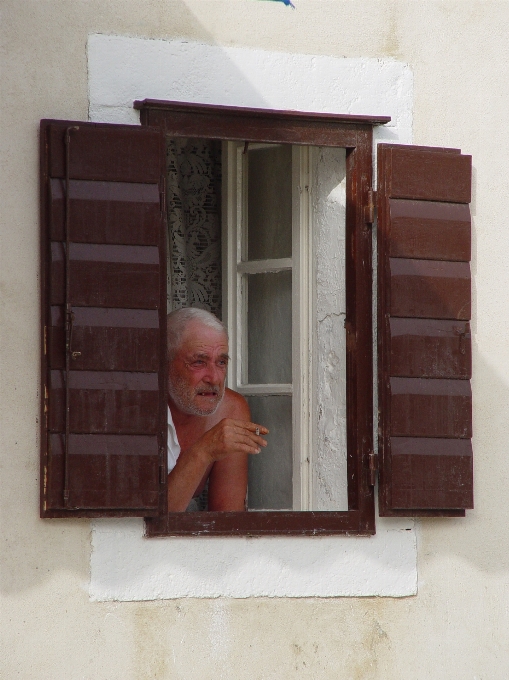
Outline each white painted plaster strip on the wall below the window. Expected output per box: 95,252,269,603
90,519,417,601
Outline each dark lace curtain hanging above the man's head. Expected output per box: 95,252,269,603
166,138,221,318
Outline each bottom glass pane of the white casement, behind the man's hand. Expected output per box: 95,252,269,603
247,396,293,510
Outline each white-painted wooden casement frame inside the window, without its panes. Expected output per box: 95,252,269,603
223,142,316,510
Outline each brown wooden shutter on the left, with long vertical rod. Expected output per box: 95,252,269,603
41,120,167,517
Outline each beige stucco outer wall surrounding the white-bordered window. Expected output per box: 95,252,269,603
0,0,509,680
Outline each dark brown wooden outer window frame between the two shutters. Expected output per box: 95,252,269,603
139,99,390,537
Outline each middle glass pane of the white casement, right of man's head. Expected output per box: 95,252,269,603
247,270,292,385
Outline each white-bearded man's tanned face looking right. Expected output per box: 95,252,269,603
168,321,228,416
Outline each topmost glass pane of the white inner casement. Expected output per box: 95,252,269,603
247,145,292,260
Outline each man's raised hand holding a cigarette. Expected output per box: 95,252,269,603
190,418,269,464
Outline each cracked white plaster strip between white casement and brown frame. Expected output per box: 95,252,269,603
311,148,348,510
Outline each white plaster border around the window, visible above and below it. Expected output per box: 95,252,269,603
88,35,417,601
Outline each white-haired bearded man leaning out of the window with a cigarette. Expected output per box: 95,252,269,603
168,308,268,512
